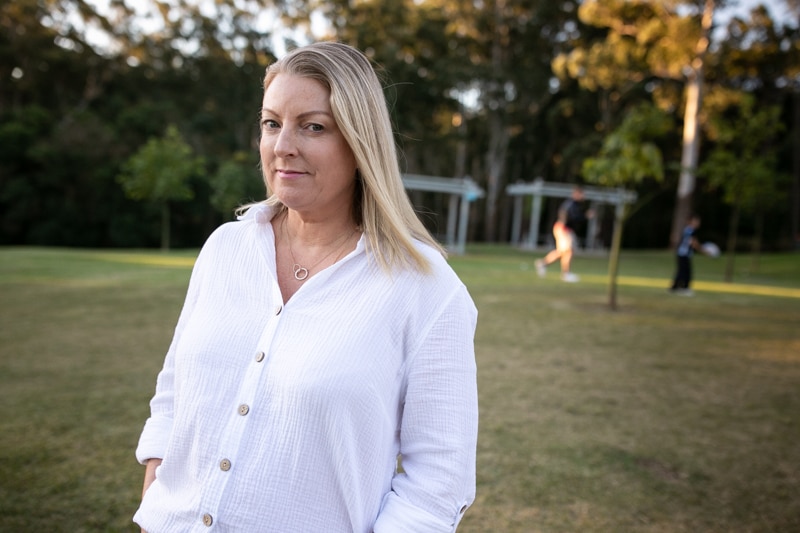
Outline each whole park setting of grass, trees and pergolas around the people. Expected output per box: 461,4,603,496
0,0,800,533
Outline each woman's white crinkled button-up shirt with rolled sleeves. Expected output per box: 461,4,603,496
134,206,478,533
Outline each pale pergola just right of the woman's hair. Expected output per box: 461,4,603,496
403,174,485,255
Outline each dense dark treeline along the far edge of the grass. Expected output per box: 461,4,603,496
0,0,800,249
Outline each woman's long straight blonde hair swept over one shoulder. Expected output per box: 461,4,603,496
250,42,446,272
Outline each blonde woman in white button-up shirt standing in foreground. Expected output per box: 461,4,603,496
134,43,478,533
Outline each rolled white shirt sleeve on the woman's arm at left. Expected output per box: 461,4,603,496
136,243,203,464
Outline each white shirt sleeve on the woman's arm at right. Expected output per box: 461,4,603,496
374,285,478,533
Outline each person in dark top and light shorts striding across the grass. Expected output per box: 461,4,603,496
534,186,594,283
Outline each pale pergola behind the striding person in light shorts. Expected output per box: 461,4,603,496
506,178,637,250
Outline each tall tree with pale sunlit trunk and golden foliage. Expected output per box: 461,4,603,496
554,0,724,244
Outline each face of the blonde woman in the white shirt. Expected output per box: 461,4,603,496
260,74,356,219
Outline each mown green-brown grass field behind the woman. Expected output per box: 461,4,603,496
0,246,800,533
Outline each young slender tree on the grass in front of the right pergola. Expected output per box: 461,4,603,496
583,104,672,310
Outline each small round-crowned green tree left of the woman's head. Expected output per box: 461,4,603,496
117,125,203,250
